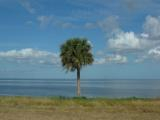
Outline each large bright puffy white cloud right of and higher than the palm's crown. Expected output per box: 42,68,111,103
107,31,160,52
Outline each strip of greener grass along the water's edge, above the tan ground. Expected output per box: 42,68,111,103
0,96,160,107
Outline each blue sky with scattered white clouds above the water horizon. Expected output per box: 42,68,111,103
0,0,160,79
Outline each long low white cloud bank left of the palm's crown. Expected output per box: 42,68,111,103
0,48,60,65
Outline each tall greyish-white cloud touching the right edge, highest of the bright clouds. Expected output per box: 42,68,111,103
143,16,160,40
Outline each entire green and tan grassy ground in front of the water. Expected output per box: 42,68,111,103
0,97,160,120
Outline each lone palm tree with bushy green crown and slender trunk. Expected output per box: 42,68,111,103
60,38,94,96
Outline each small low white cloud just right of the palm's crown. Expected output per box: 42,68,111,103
95,54,128,64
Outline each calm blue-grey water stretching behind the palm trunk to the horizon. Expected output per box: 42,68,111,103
0,79,160,98
